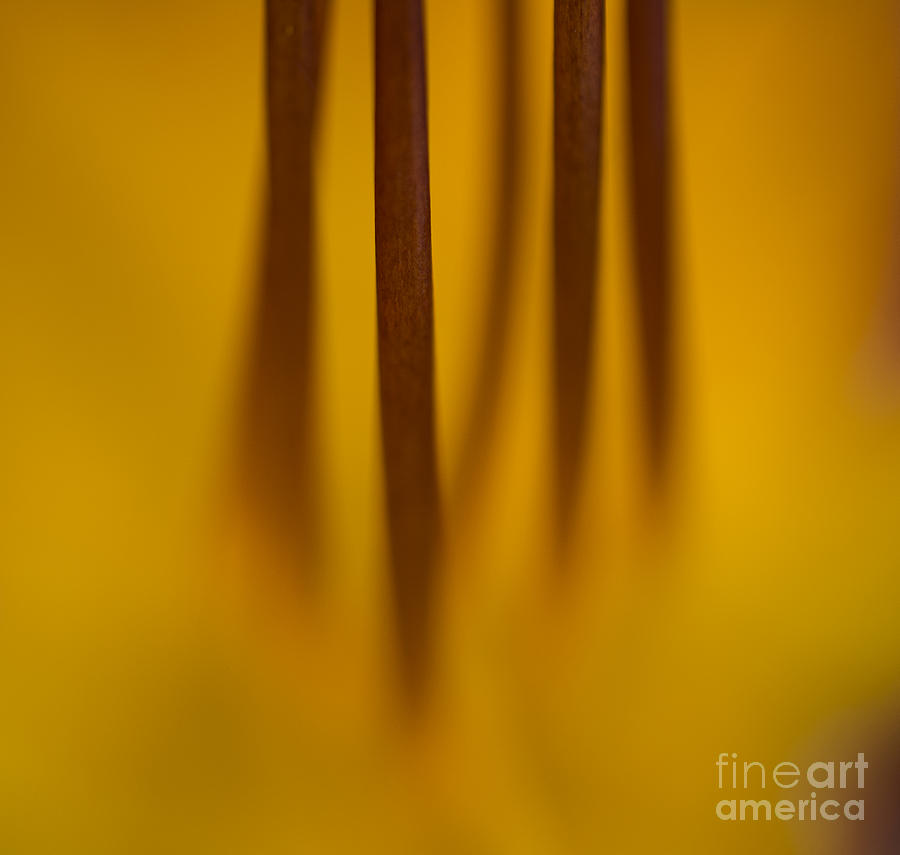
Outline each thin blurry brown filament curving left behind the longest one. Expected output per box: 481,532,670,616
455,0,525,510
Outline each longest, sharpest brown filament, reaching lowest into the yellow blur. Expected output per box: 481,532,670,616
375,0,439,687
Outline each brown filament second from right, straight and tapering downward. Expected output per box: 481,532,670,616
553,0,606,537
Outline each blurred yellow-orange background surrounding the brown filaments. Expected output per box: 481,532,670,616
0,0,900,855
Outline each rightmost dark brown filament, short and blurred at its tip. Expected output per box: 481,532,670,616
628,0,672,476
